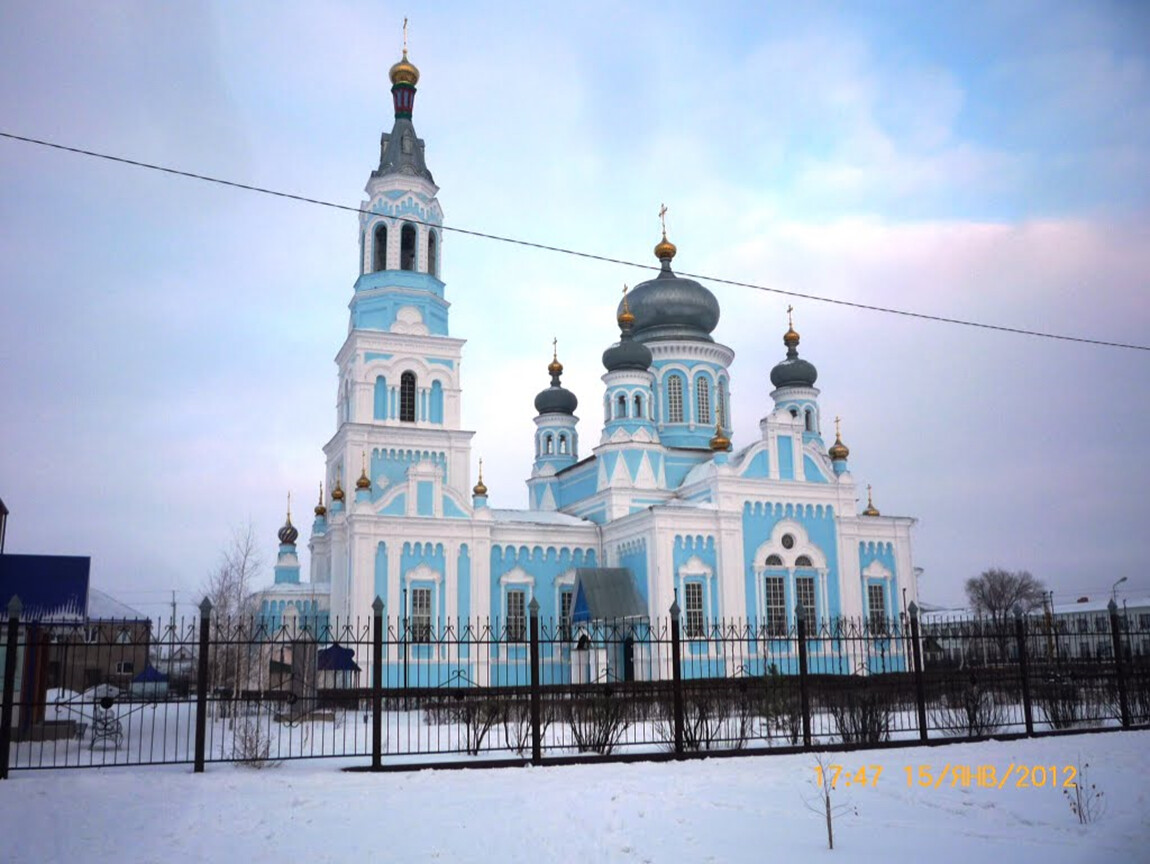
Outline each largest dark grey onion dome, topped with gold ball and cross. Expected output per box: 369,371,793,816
619,235,719,342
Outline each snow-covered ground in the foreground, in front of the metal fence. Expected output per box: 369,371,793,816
0,732,1150,864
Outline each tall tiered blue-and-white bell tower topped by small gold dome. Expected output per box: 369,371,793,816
324,37,474,525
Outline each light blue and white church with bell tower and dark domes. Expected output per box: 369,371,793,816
256,49,917,685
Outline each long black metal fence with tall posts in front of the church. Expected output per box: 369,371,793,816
0,601,1150,777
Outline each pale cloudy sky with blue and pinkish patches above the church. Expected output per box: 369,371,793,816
0,0,1150,615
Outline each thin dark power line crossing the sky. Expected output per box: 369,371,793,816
0,131,1150,352
